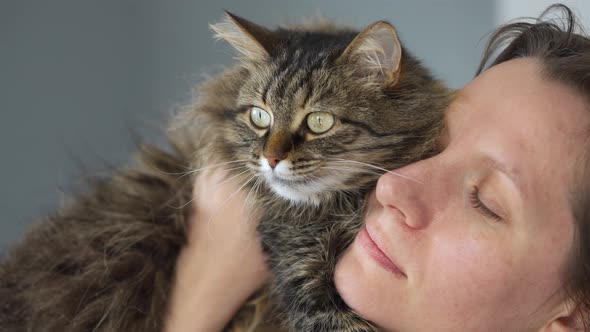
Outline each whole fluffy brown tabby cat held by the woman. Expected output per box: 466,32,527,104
0,13,451,332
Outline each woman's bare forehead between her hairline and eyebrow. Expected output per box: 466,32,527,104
447,59,590,152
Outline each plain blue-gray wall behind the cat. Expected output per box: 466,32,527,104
0,0,495,252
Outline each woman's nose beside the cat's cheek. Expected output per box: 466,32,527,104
375,161,432,229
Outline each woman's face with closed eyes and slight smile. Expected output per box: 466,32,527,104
334,59,590,331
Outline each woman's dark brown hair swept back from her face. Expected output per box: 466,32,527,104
476,4,590,330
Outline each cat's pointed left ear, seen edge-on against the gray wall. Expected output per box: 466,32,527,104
209,11,276,61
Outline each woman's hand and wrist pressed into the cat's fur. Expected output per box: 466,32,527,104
166,170,270,332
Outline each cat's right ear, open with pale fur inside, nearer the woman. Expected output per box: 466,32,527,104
338,21,402,85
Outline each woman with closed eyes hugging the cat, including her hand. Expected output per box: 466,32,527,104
168,7,590,331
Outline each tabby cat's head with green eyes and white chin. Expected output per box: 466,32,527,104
211,13,447,204
